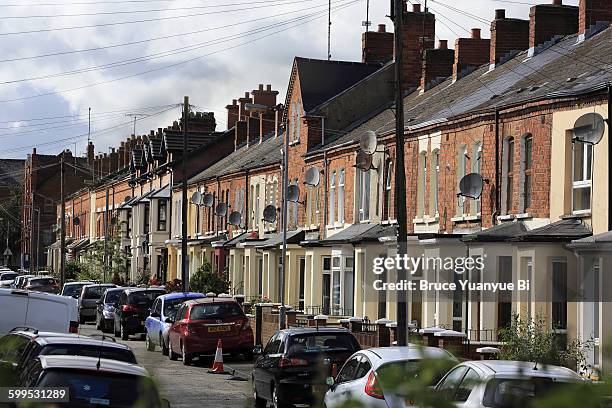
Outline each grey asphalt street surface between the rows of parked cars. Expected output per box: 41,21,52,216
79,324,254,408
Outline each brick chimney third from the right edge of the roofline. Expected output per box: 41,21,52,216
489,9,529,66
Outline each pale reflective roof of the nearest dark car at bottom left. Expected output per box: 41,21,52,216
38,356,149,377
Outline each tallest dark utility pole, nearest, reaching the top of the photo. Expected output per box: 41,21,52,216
393,0,408,346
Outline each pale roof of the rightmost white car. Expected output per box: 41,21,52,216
462,360,582,380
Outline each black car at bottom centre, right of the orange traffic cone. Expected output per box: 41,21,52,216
253,327,361,408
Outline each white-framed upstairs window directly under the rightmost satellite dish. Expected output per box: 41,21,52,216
572,141,593,214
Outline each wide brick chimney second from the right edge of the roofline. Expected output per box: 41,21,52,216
529,0,580,56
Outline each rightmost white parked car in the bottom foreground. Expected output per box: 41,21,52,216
436,360,584,408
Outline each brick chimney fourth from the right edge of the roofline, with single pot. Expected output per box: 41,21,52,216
453,28,491,81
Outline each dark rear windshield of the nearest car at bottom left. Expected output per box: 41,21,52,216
36,369,161,408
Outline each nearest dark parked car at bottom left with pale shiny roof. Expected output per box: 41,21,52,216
19,356,170,408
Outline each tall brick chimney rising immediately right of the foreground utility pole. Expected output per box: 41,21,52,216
394,2,436,89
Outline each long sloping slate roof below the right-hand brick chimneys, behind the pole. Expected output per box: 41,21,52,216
313,27,612,153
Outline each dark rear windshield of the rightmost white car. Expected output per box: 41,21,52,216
483,378,565,408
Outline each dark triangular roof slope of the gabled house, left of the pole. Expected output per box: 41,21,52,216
294,57,381,112
